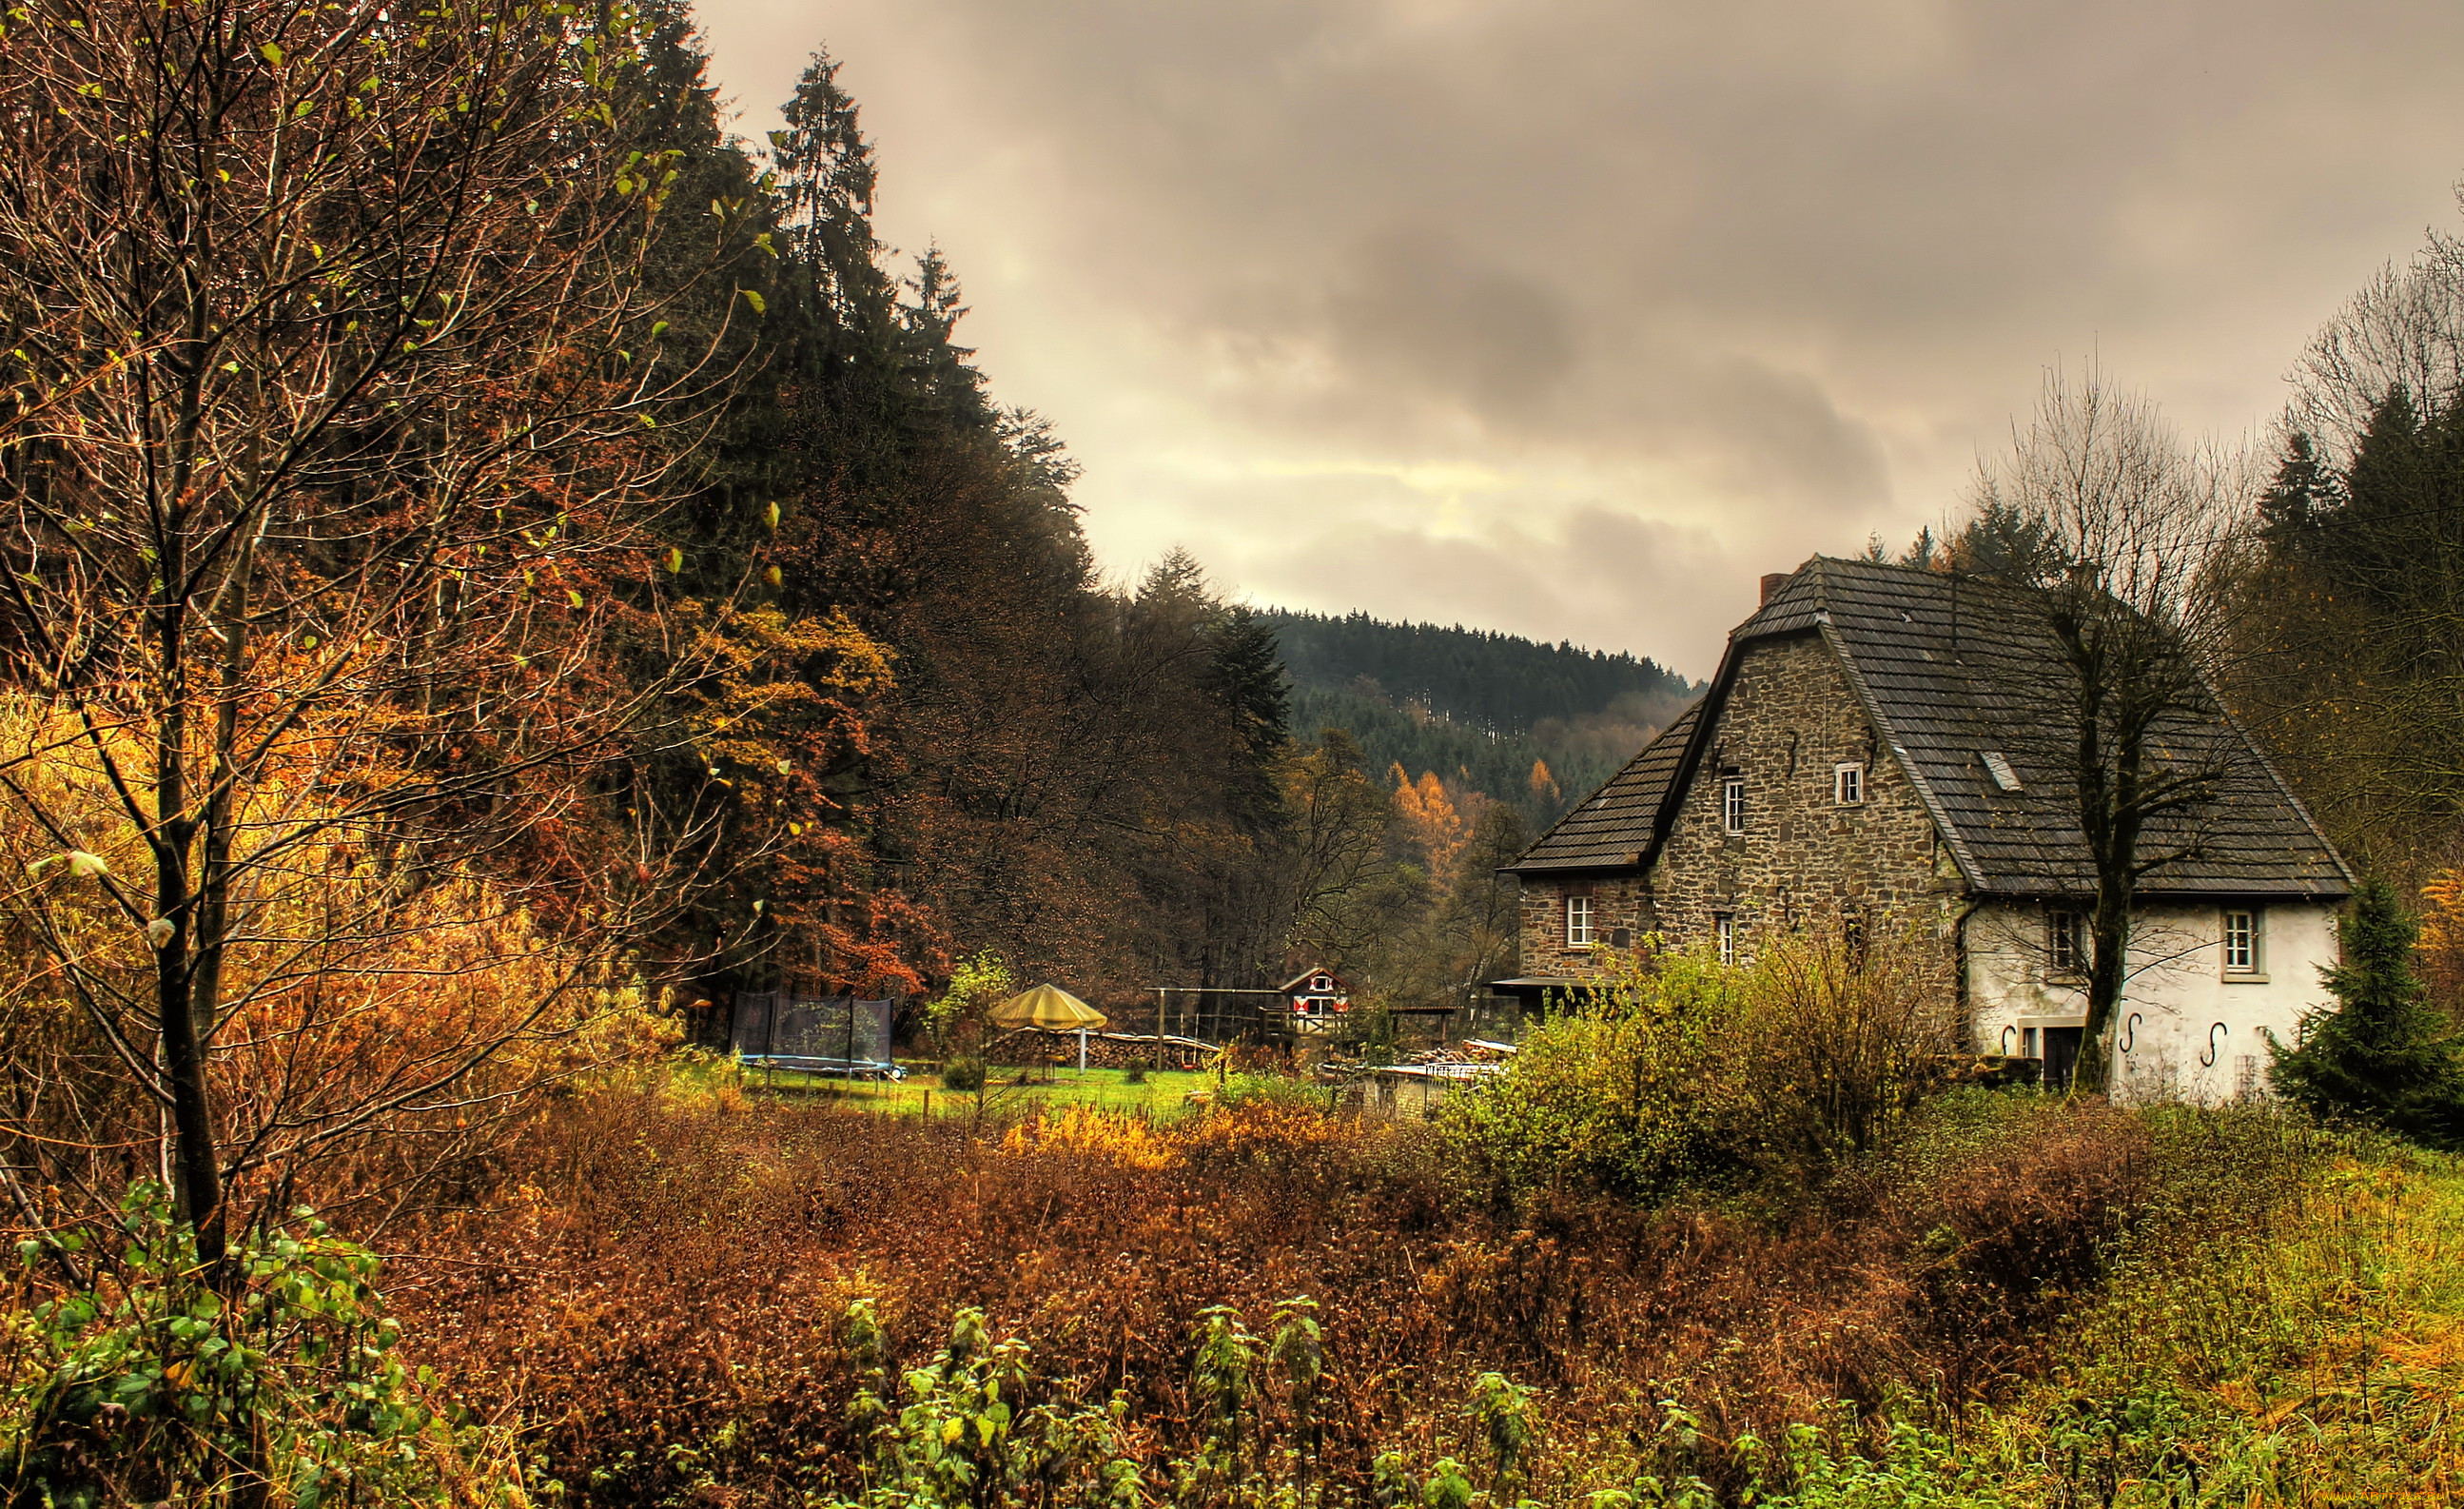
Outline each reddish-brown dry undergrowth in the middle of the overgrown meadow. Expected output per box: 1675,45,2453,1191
392,1088,2286,1504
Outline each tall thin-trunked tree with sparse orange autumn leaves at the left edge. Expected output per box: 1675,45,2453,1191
0,0,756,1260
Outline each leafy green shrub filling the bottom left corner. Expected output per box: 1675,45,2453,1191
0,1186,519,1509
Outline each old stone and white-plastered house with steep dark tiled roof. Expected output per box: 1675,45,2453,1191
1494,558,2353,1100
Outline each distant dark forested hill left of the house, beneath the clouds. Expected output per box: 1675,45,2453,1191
1259,609,1700,826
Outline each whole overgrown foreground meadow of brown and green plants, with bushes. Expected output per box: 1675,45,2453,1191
0,945,2464,1509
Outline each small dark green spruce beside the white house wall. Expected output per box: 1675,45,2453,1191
2275,880,2464,1146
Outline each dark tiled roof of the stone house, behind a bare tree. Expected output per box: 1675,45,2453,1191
1516,558,2351,897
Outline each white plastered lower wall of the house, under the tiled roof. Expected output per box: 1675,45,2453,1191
1964,902,2336,1105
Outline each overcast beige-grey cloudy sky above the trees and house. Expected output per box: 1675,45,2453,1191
702,0,2464,676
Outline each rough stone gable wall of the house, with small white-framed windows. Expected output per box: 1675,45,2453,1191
1651,634,1959,979
